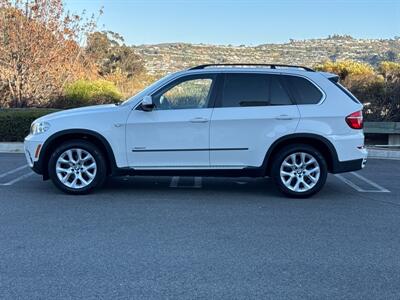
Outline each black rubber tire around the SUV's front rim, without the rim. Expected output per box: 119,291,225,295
48,140,107,195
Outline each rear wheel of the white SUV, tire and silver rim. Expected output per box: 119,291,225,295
272,145,328,198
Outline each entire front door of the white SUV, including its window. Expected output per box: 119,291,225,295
126,75,214,169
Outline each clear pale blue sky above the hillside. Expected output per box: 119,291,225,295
65,0,400,46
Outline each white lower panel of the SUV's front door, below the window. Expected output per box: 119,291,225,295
126,108,212,168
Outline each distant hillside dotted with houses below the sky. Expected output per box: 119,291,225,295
133,35,400,75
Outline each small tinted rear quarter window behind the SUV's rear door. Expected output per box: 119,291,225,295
285,76,323,104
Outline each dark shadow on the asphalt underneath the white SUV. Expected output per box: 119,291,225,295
33,176,349,202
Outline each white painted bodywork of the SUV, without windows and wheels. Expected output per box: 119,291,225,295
25,68,367,178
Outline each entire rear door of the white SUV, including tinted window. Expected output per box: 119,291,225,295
210,73,299,168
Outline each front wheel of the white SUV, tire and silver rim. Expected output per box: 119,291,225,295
49,140,107,194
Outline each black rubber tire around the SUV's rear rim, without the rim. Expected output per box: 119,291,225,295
271,144,328,198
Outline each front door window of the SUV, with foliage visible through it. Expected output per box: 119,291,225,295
153,78,213,110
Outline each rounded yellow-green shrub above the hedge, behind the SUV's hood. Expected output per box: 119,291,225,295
54,80,122,108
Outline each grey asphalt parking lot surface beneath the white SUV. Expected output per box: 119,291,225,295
0,154,400,299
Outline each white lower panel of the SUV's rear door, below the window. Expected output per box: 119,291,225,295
210,105,299,168
